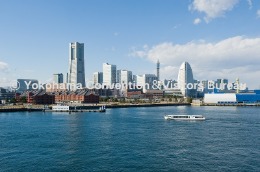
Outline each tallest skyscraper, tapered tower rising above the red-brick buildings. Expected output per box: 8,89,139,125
67,42,86,87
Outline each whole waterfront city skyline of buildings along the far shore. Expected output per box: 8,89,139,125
0,42,260,104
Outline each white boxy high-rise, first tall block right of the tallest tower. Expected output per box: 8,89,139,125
103,63,116,85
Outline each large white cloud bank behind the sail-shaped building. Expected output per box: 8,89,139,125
132,36,260,86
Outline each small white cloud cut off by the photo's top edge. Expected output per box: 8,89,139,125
189,0,239,22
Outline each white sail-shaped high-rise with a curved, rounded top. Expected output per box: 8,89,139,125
178,62,194,97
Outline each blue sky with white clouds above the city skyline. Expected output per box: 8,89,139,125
0,0,260,89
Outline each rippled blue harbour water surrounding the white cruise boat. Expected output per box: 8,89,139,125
0,106,260,172
